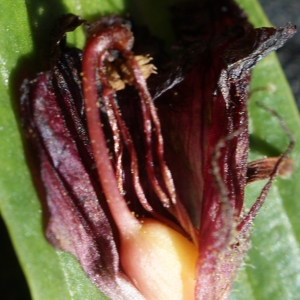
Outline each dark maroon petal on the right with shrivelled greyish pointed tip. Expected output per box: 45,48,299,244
157,18,295,299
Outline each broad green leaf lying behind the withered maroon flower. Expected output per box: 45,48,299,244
0,0,300,300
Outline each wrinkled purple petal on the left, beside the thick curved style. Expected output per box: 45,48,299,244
22,49,143,299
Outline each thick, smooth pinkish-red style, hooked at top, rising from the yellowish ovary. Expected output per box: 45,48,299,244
82,25,140,236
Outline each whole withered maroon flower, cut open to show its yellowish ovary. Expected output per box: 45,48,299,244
22,0,295,300
